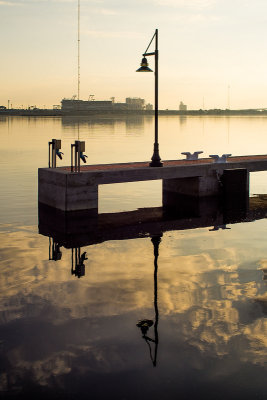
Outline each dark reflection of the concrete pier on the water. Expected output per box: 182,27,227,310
39,197,267,248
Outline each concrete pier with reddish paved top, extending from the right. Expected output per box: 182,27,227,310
39,155,267,212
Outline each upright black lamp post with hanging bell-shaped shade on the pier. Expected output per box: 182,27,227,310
136,29,163,167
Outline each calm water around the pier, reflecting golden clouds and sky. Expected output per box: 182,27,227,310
0,117,267,400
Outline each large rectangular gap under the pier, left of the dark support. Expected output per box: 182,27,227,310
98,180,162,213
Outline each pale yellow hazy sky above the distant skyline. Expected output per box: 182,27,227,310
0,0,267,109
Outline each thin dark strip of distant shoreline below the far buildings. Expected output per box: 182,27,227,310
0,108,267,117
